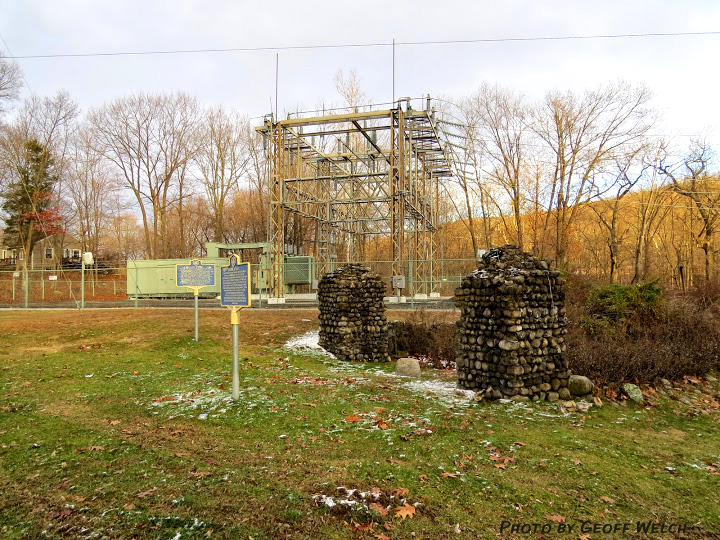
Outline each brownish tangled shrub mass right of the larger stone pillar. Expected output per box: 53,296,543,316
566,282,720,385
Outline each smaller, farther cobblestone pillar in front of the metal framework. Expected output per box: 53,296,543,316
318,264,390,362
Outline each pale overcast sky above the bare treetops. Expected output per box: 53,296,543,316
0,0,720,150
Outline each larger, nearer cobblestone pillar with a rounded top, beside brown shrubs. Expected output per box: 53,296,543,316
455,245,570,401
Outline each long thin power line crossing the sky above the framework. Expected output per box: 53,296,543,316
5,30,720,60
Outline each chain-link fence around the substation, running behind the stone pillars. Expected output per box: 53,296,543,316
0,257,476,308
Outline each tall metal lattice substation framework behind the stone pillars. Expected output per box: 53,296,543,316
257,96,462,298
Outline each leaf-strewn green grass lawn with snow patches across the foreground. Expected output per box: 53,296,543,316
0,310,720,540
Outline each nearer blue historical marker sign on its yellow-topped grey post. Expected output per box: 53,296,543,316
220,254,250,400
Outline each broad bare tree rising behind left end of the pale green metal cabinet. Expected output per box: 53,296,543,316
89,93,198,258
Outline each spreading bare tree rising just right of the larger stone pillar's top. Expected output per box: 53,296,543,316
533,82,653,268
